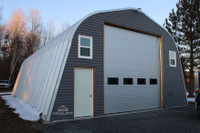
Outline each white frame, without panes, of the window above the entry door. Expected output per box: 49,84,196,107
78,35,93,59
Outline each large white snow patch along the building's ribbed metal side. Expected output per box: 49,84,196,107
2,95,40,121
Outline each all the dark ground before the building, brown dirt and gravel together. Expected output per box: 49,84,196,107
0,89,200,133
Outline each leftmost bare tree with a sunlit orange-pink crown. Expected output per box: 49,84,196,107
7,8,27,80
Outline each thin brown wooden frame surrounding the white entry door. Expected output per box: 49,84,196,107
73,67,95,119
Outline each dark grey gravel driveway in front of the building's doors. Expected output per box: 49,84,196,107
38,106,200,133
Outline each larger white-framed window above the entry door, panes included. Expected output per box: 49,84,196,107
78,35,93,59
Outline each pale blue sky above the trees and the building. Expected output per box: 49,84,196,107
0,0,178,28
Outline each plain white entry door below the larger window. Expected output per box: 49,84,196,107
74,68,93,118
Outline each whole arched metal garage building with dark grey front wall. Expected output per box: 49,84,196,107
12,8,187,121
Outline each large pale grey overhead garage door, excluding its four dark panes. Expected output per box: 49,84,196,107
104,26,160,114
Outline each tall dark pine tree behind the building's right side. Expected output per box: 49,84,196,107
164,0,200,96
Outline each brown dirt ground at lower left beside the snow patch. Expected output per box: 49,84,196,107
0,89,42,133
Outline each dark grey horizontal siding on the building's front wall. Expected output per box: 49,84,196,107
51,10,186,120
